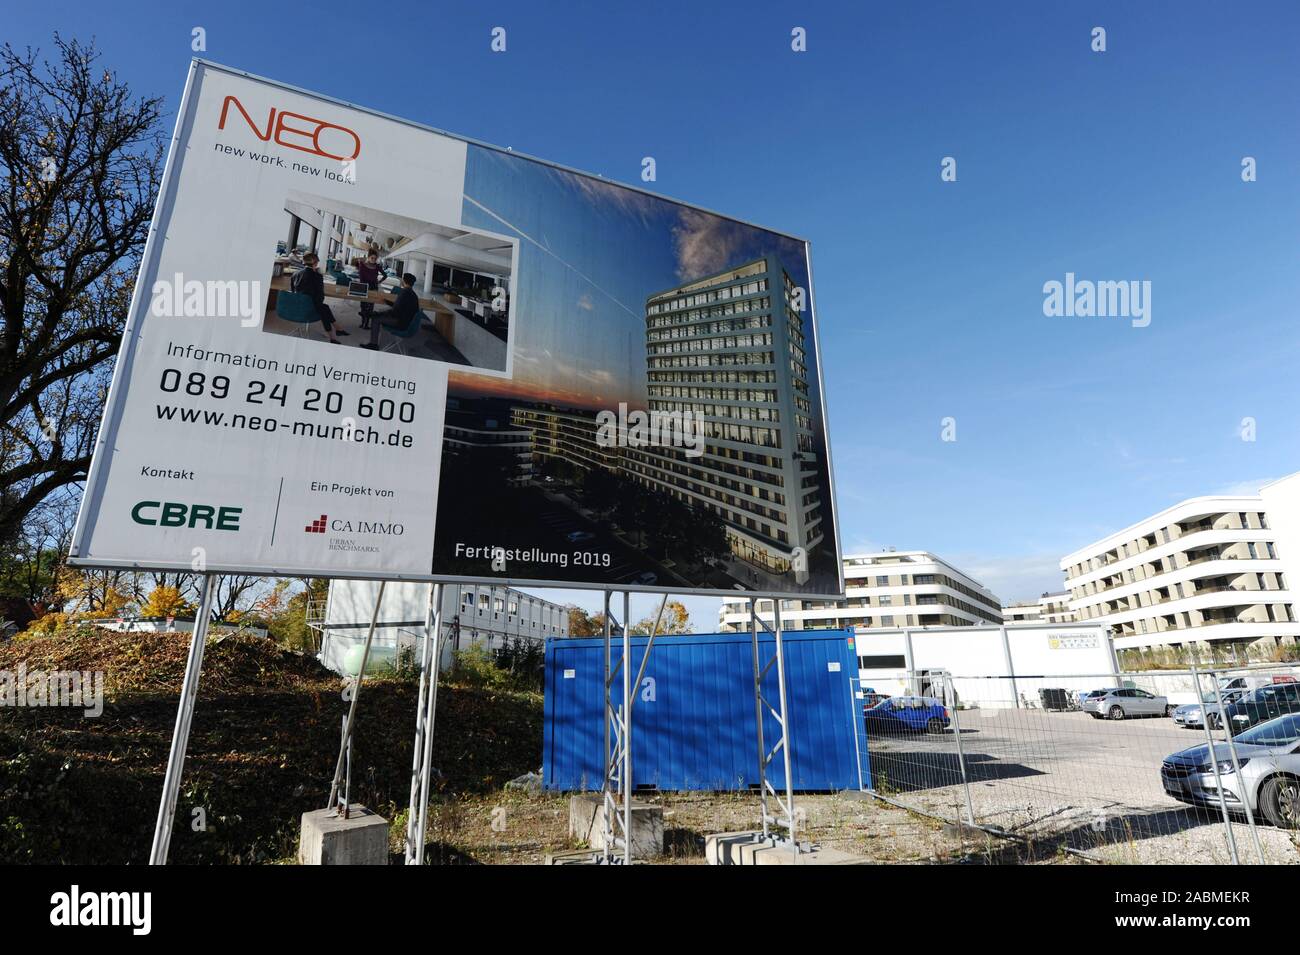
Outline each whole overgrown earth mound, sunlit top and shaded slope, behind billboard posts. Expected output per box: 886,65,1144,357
0,631,542,864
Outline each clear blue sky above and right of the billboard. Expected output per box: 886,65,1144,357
5,0,1300,629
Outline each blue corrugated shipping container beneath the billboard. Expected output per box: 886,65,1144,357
542,630,868,790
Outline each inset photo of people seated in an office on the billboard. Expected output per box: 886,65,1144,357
263,192,515,372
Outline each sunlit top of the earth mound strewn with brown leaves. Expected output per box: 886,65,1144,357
0,628,337,696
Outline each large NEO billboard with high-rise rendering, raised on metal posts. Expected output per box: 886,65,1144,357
73,61,842,595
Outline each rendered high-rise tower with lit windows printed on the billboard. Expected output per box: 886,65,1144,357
623,257,823,582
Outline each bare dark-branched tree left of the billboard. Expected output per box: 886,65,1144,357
0,35,164,542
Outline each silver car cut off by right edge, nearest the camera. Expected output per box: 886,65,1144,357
1160,713,1300,829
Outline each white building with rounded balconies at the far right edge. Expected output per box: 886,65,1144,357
1061,474,1300,650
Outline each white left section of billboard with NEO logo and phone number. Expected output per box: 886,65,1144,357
73,64,514,578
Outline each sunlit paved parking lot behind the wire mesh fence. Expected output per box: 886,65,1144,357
868,709,1300,863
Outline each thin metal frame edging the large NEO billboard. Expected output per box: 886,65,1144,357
69,57,845,599
